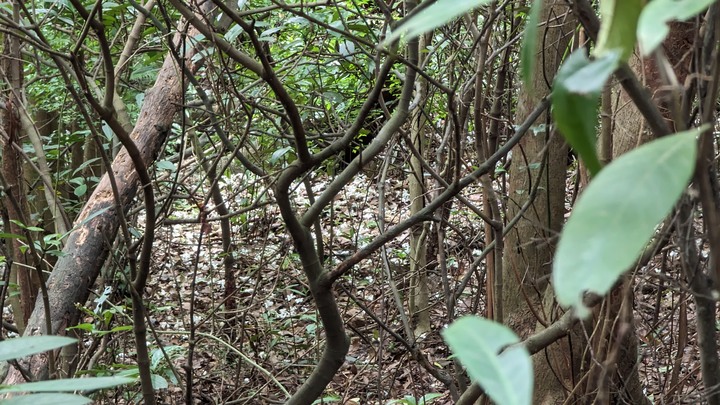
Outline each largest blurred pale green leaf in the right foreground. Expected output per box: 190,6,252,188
552,128,702,317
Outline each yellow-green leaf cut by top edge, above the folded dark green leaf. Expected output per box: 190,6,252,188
594,0,645,62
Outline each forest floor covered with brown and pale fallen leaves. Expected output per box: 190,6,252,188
57,162,700,405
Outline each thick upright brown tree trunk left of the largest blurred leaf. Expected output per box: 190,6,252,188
496,0,582,404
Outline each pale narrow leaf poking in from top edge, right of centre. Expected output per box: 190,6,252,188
380,0,491,48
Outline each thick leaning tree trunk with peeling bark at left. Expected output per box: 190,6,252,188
4,23,205,384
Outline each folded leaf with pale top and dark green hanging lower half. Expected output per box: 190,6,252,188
552,49,620,175
